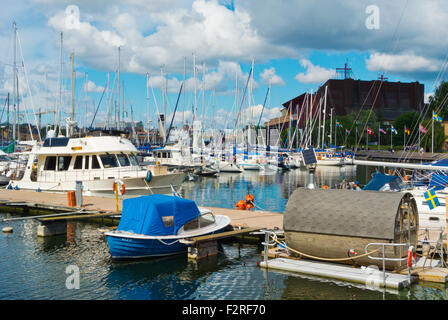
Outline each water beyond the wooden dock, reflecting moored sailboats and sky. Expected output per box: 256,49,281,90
181,166,357,212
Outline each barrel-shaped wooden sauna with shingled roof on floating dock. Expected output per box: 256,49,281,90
283,188,418,270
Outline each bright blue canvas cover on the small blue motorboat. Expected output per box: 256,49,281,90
117,194,200,236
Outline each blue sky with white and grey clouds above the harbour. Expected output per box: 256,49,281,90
0,0,448,128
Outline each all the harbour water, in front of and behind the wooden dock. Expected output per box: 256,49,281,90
0,167,447,300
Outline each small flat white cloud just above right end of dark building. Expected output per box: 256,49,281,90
366,52,441,72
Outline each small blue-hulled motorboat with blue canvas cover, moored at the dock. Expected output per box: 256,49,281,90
105,194,230,260
